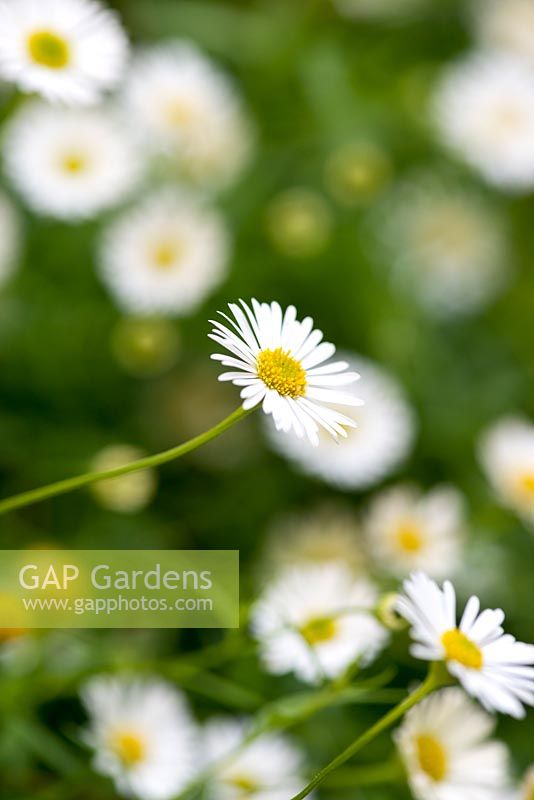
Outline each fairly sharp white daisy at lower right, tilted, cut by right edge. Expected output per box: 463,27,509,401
397,572,534,718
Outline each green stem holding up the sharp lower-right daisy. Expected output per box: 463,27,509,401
291,663,450,800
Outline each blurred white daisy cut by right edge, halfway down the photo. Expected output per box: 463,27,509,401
479,417,534,523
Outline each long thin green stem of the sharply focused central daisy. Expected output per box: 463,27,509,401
0,408,251,515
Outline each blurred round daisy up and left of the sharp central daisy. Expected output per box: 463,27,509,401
100,189,229,316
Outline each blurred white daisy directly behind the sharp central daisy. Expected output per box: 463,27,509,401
268,355,414,489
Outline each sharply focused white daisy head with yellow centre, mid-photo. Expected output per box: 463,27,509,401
209,300,362,445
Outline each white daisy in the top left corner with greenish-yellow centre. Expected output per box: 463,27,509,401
0,0,128,105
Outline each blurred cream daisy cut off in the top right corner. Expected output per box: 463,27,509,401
473,0,534,61
